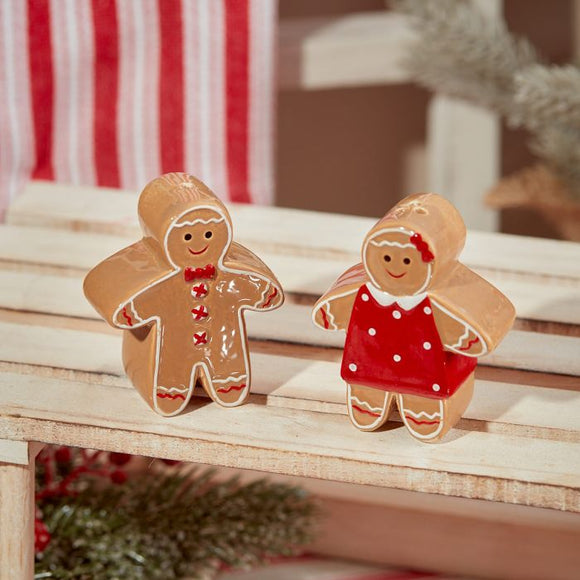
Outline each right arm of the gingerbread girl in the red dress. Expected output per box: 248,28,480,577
431,299,491,357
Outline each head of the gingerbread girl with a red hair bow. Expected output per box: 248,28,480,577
362,193,465,296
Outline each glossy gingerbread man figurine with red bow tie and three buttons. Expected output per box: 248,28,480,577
84,173,284,416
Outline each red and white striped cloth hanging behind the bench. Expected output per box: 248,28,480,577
0,0,277,214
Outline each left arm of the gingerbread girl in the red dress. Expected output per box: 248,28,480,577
312,264,368,331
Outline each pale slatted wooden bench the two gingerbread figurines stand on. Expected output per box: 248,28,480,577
0,182,580,580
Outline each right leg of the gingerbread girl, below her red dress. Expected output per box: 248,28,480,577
397,373,474,443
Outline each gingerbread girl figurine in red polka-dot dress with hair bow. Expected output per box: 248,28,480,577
313,193,515,442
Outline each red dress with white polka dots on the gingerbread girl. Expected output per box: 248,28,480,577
341,285,477,399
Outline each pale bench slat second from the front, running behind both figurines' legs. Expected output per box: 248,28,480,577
0,322,580,442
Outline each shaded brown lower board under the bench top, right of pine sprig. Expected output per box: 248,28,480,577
197,463,580,580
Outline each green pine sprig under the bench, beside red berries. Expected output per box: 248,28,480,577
35,469,317,580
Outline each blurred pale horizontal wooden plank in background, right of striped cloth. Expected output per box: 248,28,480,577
278,11,412,89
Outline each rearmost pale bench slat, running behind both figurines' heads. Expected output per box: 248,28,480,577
7,181,580,286
